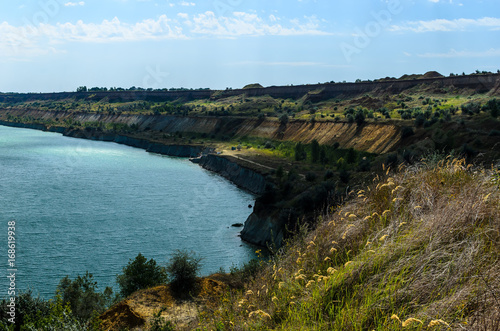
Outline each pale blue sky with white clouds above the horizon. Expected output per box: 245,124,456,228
0,0,500,92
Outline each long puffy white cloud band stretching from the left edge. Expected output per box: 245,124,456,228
0,11,329,57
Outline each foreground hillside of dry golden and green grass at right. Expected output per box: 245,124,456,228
194,158,500,330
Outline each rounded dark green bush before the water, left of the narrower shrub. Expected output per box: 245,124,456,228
116,253,167,297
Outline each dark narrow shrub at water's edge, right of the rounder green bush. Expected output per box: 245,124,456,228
167,250,201,297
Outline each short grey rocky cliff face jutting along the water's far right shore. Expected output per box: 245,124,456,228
199,154,266,194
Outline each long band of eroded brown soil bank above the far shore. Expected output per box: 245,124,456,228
0,108,402,154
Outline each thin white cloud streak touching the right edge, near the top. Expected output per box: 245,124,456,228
390,17,500,32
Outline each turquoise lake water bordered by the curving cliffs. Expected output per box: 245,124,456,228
0,126,254,298
